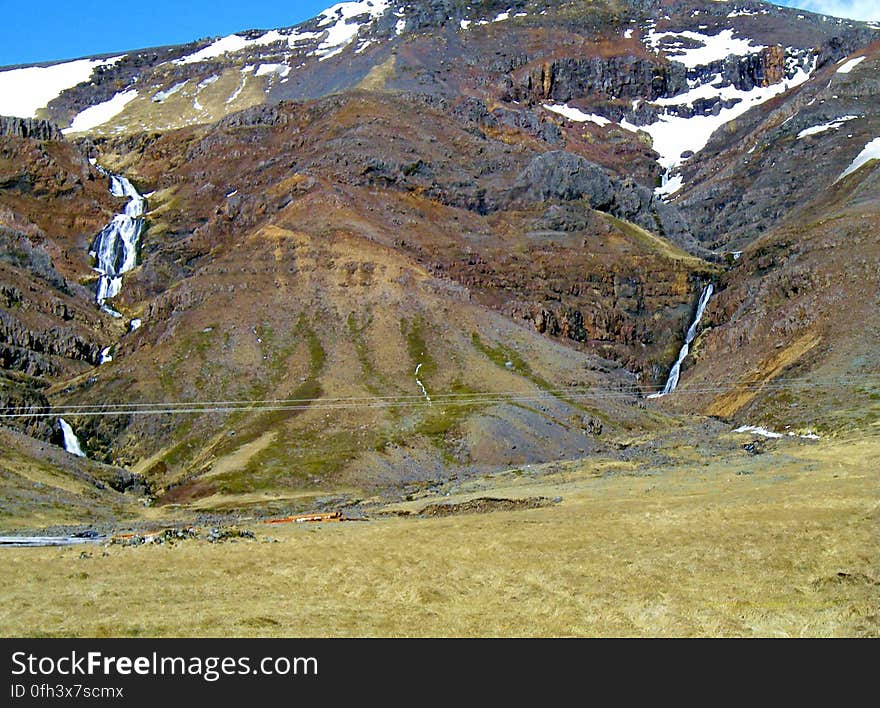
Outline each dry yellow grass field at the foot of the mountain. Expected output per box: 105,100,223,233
0,437,880,637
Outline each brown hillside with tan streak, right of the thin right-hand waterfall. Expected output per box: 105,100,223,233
678,163,880,435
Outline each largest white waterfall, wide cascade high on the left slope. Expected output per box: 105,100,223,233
89,167,144,316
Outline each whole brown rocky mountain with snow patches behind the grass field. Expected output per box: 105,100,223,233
0,0,880,510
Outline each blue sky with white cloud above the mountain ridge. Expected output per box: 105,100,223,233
0,0,880,66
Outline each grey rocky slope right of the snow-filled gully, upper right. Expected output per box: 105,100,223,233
675,40,880,250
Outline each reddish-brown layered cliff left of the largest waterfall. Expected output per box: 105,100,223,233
0,130,119,440
